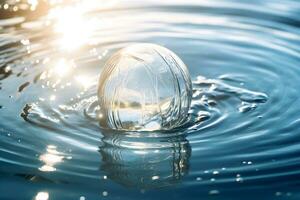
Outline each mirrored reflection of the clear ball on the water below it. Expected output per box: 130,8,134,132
99,135,191,189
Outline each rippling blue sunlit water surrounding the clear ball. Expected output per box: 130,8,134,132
0,0,300,200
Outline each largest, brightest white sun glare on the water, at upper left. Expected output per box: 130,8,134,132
49,4,94,50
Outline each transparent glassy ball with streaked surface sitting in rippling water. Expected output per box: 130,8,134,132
98,43,192,131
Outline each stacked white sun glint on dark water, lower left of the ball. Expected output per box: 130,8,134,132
39,145,64,172
